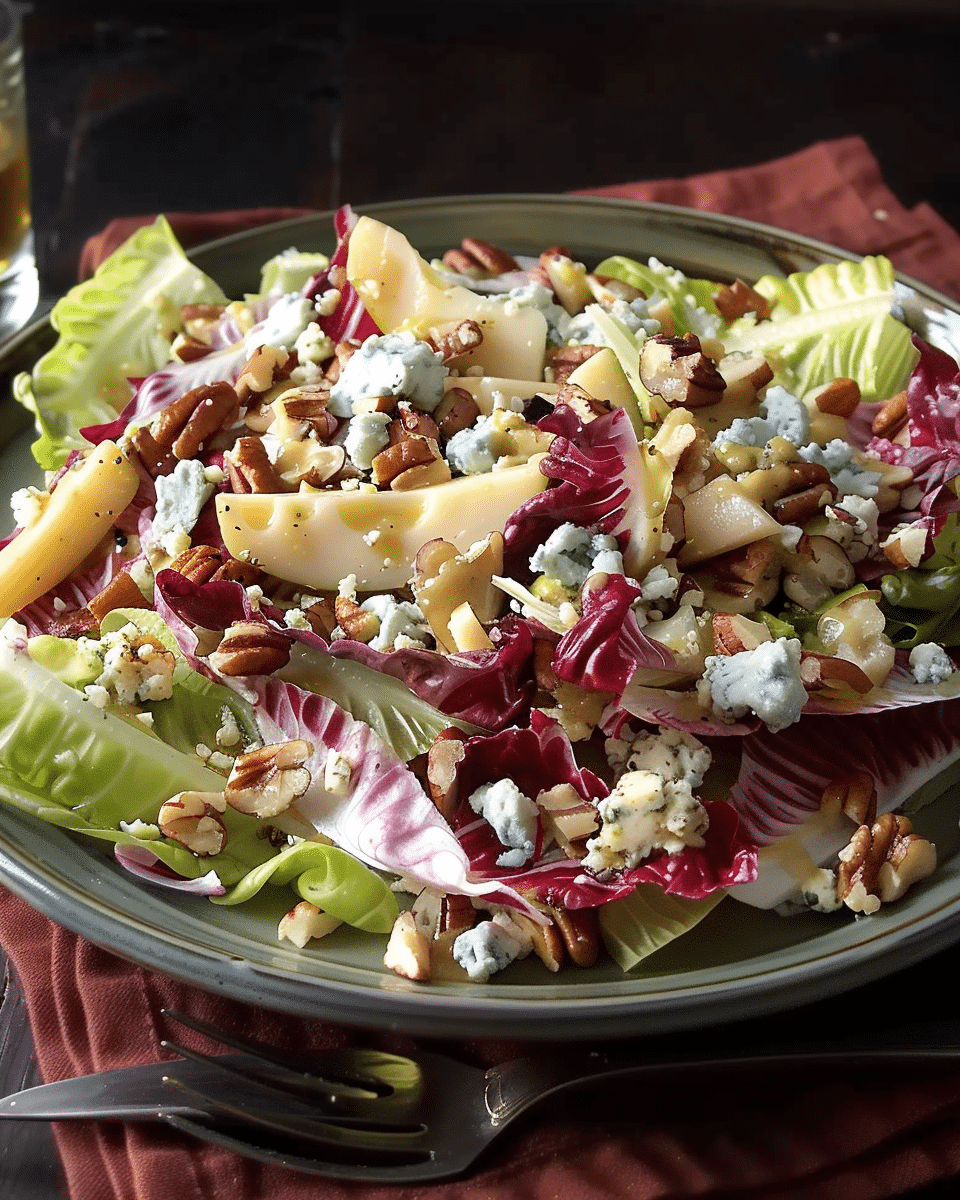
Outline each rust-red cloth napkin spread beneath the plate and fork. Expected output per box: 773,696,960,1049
0,138,960,1200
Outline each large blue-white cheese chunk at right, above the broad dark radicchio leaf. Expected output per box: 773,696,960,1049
701,637,806,733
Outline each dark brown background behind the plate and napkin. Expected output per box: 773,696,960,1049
13,0,960,295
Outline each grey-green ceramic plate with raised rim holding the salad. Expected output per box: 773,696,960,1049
0,196,960,1037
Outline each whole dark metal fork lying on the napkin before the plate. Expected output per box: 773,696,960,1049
148,1013,960,1183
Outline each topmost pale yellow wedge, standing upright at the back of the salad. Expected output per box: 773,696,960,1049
347,216,547,379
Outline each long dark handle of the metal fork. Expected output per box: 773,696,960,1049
485,1027,960,1124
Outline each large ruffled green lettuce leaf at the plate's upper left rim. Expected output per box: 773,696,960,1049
13,216,227,470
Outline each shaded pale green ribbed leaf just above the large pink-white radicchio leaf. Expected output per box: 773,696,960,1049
276,646,482,762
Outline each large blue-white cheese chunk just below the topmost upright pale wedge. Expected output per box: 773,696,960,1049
330,332,446,416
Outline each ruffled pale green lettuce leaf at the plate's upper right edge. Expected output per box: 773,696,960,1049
719,256,918,400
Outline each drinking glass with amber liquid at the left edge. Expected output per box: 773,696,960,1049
0,0,40,342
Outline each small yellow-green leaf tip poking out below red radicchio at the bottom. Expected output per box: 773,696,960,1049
599,883,726,972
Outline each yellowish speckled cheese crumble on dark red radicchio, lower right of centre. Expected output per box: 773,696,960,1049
583,770,709,871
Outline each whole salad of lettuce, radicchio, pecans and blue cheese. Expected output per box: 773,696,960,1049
0,208,960,982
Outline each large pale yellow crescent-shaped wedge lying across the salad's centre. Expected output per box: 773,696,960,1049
217,455,547,592
